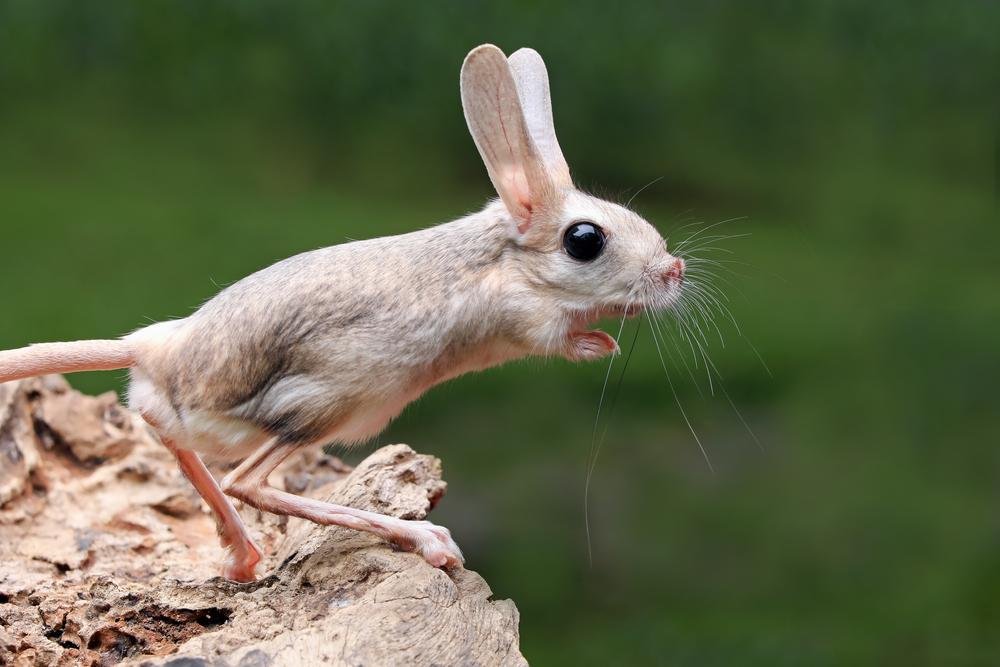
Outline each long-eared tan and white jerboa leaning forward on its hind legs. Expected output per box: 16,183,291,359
0,44,684,581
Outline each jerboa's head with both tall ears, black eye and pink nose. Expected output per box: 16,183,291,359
461,44,684,356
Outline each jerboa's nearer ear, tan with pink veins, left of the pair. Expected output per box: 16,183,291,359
461,44,556,234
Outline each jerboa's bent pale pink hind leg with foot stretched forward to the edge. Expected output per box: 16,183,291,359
222,440,462,567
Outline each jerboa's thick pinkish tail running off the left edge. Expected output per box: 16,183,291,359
0,340,135,382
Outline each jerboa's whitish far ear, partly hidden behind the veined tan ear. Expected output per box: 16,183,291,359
507,49,573,187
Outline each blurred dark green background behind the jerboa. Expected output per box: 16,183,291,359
0,0,1000,665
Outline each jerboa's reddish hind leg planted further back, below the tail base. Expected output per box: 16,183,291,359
152,435,260,582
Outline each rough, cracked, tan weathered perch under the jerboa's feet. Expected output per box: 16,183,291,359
0,377,525,667
